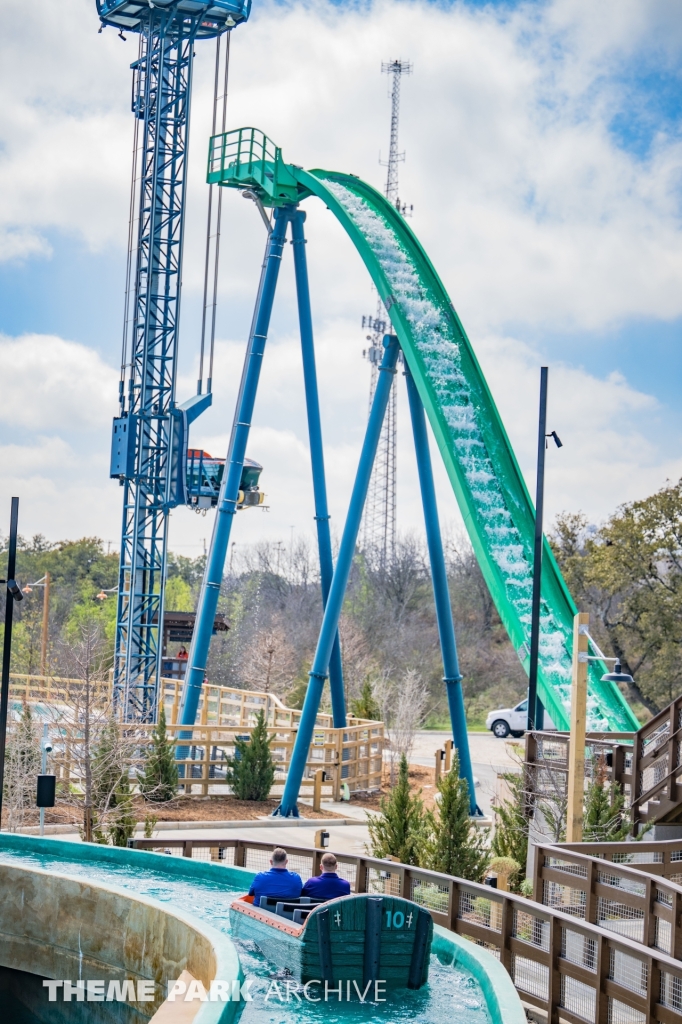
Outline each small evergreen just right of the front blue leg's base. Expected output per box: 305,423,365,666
367,754,426,866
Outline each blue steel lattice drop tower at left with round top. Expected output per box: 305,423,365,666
96,0,251,722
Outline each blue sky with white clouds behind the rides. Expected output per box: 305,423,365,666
0,0,682,555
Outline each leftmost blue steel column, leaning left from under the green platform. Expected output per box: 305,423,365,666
178,207,291,729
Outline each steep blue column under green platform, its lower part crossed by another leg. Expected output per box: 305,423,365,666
291,210,346,729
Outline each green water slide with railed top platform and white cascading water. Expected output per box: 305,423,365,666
208,128,639,732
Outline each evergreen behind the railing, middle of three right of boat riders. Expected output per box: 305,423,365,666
428,752,489,882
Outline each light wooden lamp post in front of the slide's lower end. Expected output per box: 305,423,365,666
566,611,590,843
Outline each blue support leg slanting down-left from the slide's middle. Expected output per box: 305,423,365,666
274,335,400,818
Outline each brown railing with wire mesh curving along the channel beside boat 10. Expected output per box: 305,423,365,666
130,839,682,1024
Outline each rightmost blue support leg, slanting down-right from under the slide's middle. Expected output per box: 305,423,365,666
406,364,480,814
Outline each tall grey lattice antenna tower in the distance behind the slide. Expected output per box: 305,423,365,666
361,60,412,567
